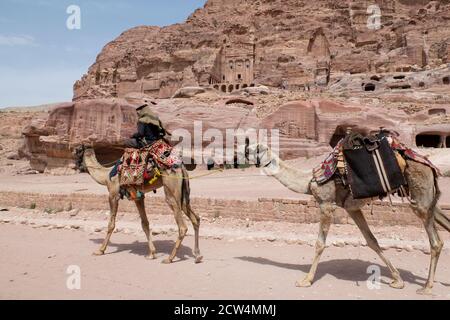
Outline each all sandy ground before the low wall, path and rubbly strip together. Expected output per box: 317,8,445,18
0,208,450,299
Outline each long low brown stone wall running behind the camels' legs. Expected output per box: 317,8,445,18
0,192,450,226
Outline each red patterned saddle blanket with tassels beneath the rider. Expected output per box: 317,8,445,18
117,140,182,186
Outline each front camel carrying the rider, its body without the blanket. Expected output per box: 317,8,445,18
78,148,203,264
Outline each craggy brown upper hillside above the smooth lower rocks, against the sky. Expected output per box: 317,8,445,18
74,0,450,100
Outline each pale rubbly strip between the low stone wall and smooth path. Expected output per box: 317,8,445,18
0,208,450,254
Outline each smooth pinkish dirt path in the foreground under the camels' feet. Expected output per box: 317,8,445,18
0,223,450,299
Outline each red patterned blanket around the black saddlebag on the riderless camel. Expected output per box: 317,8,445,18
313,136,441,194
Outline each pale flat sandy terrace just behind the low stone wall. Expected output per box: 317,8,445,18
0,169,450,203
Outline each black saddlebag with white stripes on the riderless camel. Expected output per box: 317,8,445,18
344,137,406,199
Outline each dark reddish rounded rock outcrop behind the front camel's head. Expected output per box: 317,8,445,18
23,100,137,172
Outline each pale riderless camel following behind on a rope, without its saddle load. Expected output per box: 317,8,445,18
245,144,450,294
